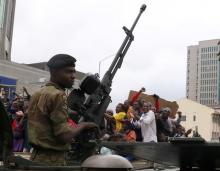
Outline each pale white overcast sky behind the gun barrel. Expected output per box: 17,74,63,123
12,0,220,109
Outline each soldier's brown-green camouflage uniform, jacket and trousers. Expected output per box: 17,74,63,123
28,82,73,165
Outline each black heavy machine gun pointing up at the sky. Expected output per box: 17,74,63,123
67,4,146,160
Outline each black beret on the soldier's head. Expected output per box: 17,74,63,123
47,54,76,69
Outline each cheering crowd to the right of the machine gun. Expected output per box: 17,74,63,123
100,88,192,142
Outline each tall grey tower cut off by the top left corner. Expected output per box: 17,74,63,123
0,0,16,61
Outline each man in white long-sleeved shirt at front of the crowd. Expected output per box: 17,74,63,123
135,102,157,142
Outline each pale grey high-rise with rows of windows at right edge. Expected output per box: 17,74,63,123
186,39,220,107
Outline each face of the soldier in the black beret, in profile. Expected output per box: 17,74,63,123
56,67,76,88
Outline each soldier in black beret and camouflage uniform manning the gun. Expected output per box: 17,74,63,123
28,54,96,165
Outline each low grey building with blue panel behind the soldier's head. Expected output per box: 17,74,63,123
0,60,85,99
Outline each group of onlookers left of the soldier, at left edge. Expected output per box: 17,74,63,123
1,87,31,152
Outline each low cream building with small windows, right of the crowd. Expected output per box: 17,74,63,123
177,98,220,142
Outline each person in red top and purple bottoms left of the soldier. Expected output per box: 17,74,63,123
12,110,24,152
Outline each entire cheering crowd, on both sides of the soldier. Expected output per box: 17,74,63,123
2,87,196,152
